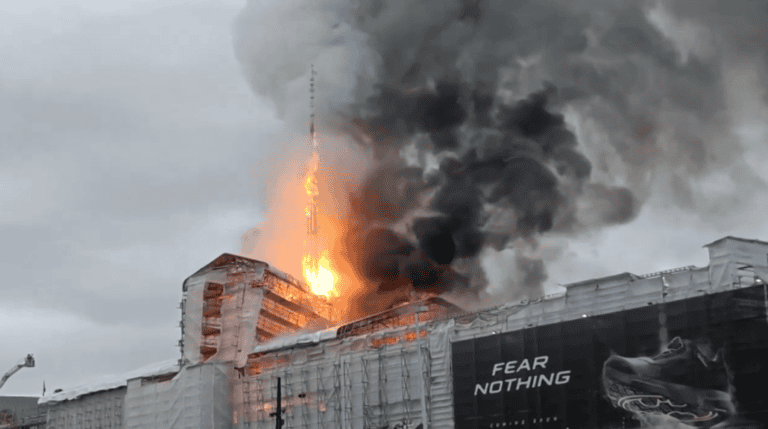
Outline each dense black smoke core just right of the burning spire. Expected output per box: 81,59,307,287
349,81,637,300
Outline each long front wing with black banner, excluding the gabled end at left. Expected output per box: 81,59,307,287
232,237,768,429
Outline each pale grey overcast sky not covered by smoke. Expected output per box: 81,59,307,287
0,0,768,395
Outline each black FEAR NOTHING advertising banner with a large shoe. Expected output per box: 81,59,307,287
453,286,768,429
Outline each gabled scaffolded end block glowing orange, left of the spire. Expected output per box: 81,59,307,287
180,253,336,367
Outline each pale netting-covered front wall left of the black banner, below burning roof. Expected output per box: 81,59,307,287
228,322,453,429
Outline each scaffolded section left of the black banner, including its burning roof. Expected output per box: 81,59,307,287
222,297,460,429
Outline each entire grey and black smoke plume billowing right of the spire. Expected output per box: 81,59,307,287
235,0,768,308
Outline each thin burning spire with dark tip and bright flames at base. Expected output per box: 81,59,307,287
301,67,335,297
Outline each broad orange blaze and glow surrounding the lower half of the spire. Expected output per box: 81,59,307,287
244,129,374,322
